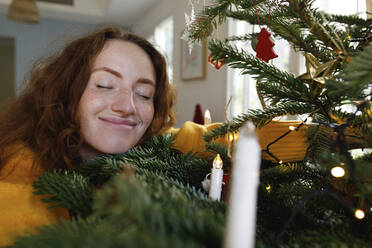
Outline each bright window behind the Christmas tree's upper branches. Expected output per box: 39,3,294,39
227,0,366,118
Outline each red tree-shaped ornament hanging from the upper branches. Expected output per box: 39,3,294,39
256,28,278,63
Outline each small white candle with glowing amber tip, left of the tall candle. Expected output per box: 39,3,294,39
209,154,223,201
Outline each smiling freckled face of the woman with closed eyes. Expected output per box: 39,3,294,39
78,40,156,160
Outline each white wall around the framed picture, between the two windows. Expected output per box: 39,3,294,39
132,0,227,127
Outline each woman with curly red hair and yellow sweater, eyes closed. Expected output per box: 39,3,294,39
0,27,175,245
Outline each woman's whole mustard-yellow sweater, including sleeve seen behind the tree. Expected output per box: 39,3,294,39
0,121,306,246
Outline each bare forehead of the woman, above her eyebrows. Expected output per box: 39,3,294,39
92,39,155,81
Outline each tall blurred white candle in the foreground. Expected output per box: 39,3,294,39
225,123,261,248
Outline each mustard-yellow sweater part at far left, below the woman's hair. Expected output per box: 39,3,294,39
0,145,69,246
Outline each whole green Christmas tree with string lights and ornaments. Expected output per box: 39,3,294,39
7,0,372,248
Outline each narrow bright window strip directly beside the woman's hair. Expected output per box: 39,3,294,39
148,16,174,82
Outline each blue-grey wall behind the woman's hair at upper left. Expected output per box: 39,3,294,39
0,14,92,92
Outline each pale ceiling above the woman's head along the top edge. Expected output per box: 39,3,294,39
0,0,161,27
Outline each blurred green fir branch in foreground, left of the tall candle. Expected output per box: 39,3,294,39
13,170,225,248
